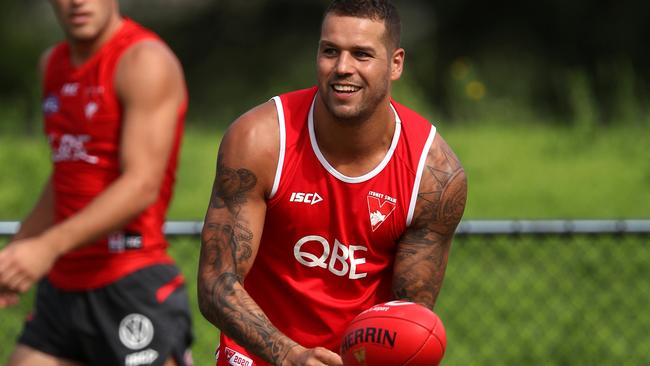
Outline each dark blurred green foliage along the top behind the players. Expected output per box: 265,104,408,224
5,0,650,133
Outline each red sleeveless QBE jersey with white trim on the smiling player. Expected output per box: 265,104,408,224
218,88,435,365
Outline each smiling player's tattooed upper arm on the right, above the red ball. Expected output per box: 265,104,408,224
392,135,467,309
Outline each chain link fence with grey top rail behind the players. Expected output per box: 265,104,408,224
0,221,650,366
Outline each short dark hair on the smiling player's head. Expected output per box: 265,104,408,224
323,0,402,48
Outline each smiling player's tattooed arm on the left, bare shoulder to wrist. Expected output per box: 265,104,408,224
198,102,296,364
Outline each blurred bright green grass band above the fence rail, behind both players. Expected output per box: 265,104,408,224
0,123,650,220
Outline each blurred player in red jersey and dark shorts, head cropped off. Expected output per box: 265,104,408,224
0,0,192,366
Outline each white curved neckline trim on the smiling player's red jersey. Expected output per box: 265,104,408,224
307,94,402,183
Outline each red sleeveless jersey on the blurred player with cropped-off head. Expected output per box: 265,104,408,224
43,19,187,290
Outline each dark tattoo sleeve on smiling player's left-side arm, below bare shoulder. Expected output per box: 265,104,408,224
199,155,295,363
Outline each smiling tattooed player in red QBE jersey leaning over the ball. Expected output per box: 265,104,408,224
198,0,467,365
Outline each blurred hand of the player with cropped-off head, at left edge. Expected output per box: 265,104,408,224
0,237,58,307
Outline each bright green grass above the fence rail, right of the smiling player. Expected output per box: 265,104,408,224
438,124,650,219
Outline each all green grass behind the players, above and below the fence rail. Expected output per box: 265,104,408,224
0,123,650,365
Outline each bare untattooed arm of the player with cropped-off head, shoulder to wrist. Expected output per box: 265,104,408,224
35,41,185,253
